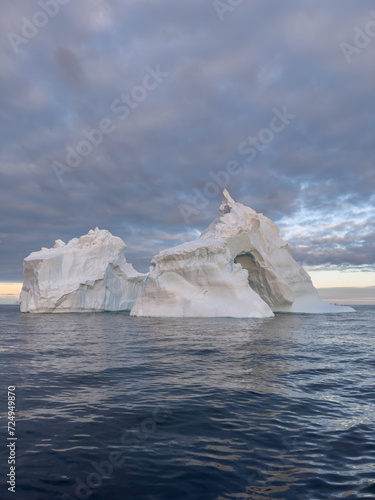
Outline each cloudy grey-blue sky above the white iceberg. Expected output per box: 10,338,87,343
0,0,375,288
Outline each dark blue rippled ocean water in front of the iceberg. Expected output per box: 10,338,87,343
0,306,375,500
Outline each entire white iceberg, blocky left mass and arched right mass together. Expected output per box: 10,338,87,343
20,190,354,318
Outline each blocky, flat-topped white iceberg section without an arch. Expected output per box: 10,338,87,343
20,228,147,312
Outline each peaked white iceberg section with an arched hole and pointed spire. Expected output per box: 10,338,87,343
131,190,353,318
